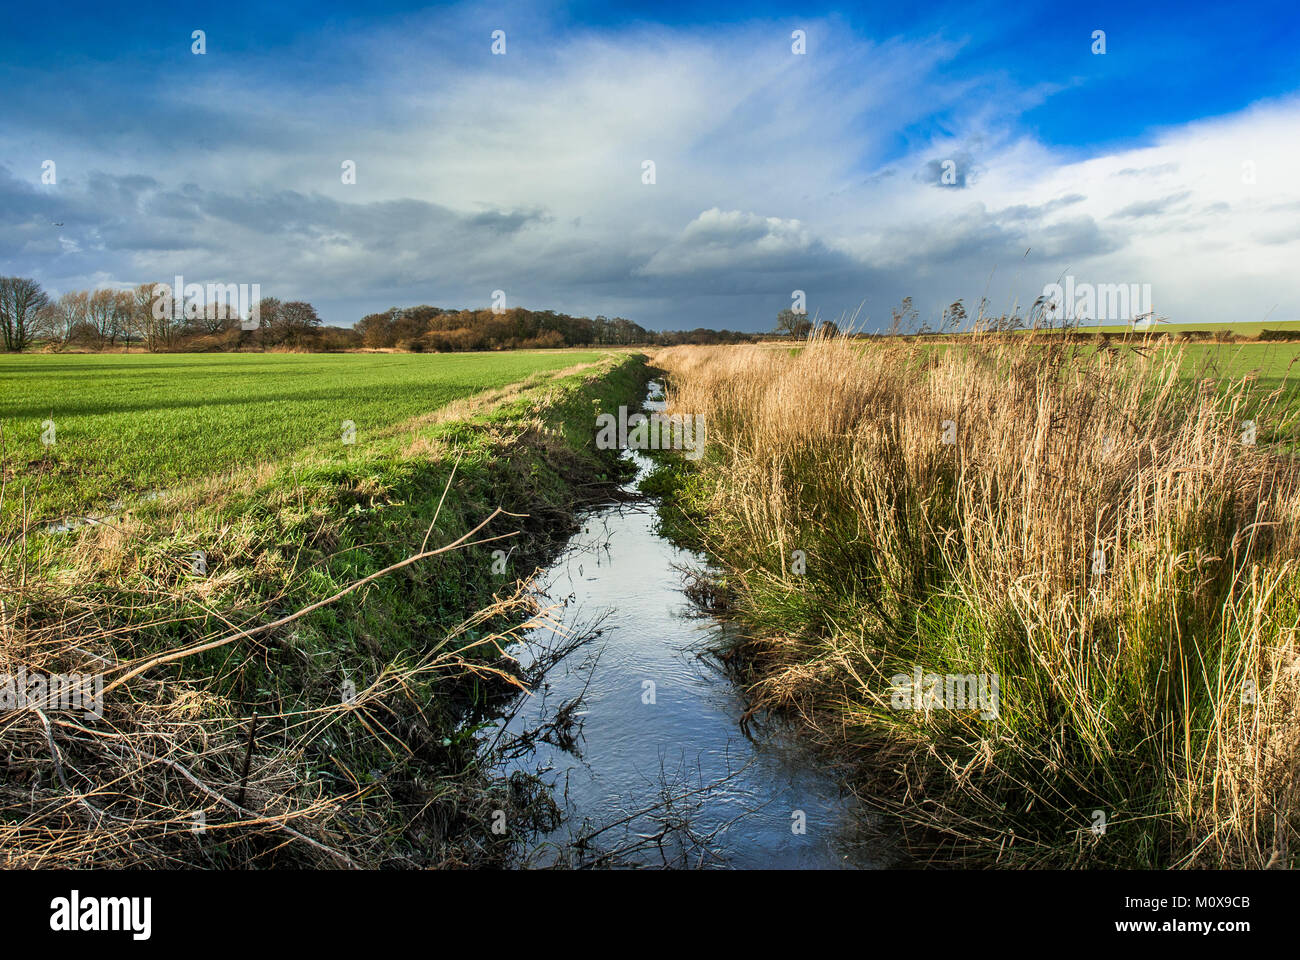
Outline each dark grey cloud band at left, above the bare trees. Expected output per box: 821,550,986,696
0,168,556,298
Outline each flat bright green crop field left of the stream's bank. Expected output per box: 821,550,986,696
0,351,599,520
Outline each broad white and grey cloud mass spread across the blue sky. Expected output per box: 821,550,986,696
0,10,1300,329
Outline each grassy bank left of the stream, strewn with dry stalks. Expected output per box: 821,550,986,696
0,354,645,868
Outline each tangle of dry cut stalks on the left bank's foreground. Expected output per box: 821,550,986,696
0,561,554,869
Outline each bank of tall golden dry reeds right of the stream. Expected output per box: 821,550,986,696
654,341,1300,868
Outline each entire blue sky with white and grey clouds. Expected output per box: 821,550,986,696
0,0,1300,330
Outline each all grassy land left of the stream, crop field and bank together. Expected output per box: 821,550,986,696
0,350,649,869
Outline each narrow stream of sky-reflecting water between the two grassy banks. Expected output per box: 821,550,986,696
494,385,894,869
